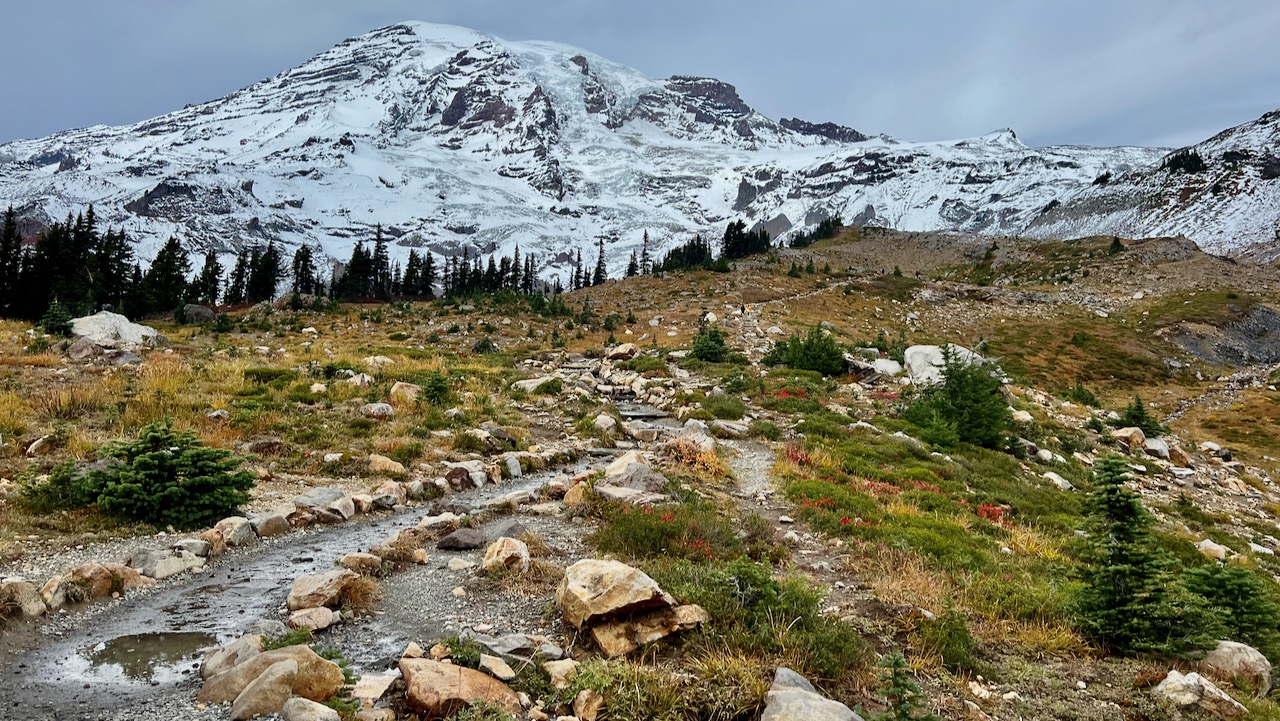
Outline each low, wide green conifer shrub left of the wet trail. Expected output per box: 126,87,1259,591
82,419,253,529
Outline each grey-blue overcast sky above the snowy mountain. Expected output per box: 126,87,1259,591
0,0,1280,146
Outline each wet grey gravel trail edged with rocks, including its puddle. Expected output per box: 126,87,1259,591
0,463,580,721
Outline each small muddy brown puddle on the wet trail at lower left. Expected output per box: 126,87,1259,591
83,633,218,684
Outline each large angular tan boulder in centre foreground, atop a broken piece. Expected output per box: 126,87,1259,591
556,558,676,630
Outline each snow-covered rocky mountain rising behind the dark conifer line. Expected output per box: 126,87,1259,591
0,23,1280,277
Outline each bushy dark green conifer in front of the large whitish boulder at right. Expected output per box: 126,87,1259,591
902,346,1012,448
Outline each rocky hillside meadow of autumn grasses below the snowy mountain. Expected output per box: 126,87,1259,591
0,229,1280,721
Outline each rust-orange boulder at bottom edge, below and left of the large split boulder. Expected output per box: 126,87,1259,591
399,658,521,718
